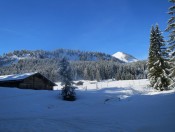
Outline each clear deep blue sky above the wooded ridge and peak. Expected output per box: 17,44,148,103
0,0,171,59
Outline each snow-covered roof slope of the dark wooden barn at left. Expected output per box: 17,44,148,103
0,72,37,81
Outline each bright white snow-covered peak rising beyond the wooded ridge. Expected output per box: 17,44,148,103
112,52,138,63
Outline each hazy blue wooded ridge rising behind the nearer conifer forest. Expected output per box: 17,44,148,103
0,49,123,66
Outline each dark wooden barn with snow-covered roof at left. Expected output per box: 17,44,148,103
0,72,56,90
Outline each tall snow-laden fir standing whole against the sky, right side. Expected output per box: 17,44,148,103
148,25,170,91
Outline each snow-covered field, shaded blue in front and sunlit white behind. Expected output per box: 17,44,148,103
0,80,175,132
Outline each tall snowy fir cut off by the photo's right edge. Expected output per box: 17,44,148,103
166,0,175,88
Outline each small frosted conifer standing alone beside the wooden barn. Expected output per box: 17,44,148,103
59,58,75,100
